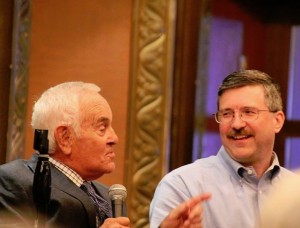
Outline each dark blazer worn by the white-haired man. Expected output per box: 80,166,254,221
0,154,110,228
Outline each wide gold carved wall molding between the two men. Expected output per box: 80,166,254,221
126,0,176,227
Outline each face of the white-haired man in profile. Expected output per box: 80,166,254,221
72,93,118,180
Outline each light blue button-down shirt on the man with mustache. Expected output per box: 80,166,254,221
150,147,294,228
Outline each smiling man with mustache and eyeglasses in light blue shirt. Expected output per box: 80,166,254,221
150,70,294,228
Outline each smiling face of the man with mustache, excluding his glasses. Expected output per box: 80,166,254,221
219,85,284,166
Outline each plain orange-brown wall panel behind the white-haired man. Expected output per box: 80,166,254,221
26,0,132,185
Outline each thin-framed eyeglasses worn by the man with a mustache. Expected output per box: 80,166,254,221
214,107,276,124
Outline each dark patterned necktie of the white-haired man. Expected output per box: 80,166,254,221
80,181,112,227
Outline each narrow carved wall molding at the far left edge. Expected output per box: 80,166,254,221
6,0,31,161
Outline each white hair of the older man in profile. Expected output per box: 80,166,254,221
31,82,101,153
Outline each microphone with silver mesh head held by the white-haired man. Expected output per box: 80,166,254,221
108,184,127,218
